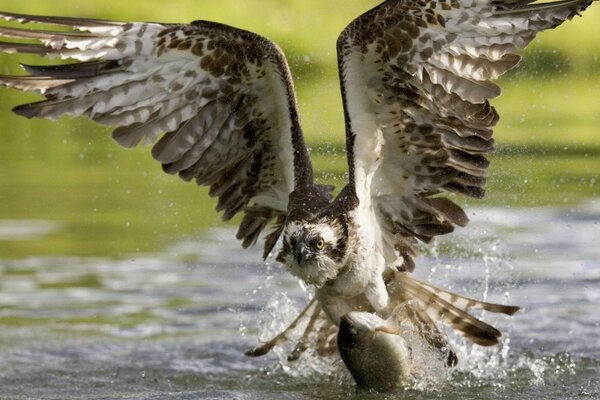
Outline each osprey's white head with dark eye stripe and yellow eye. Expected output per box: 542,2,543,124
277,218,347,287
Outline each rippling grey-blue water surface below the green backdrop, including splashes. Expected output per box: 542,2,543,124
0,205,600,399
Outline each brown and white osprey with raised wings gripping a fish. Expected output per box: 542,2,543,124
0,0,592,368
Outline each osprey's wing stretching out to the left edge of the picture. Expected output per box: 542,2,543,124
0,13,313,254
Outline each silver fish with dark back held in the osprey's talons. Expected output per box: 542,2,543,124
337,311,411,392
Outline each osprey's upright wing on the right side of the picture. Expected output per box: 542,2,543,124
338,0,592,271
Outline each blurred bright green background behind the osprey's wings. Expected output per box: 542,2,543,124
0,0,600,258
